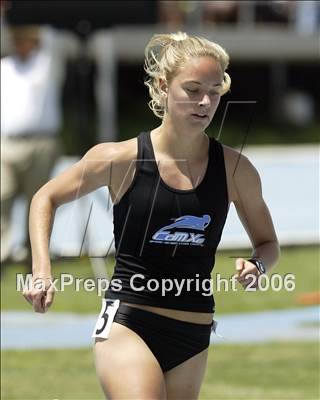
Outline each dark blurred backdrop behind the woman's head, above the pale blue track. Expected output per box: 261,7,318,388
1,1,320,155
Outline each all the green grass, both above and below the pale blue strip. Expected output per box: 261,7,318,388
1,247,320,400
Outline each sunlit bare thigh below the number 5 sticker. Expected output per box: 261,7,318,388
95,322,166,400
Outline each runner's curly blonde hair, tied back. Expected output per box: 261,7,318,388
144,32,231,119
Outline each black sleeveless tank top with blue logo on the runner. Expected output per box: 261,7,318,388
105,132,228,313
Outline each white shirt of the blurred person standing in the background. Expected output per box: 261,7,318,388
1,28,78,136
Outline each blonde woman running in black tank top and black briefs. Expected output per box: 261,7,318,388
24,32,279,400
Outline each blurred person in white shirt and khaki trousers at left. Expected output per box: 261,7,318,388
1,25,79,265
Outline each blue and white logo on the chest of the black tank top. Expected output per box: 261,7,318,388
149,214,211,246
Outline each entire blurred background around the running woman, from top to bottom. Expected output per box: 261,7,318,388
1,0,320,399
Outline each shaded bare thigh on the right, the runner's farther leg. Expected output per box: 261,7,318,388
164,349,208,400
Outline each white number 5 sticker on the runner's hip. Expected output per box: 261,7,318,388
92,299,120,339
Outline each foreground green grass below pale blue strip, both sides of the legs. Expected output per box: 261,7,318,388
1,343,320,400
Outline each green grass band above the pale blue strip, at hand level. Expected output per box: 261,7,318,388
1,246,319,314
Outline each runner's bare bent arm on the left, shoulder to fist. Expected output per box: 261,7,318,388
23,142,120,312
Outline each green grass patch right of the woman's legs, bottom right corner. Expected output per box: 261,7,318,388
200,343,320,400
